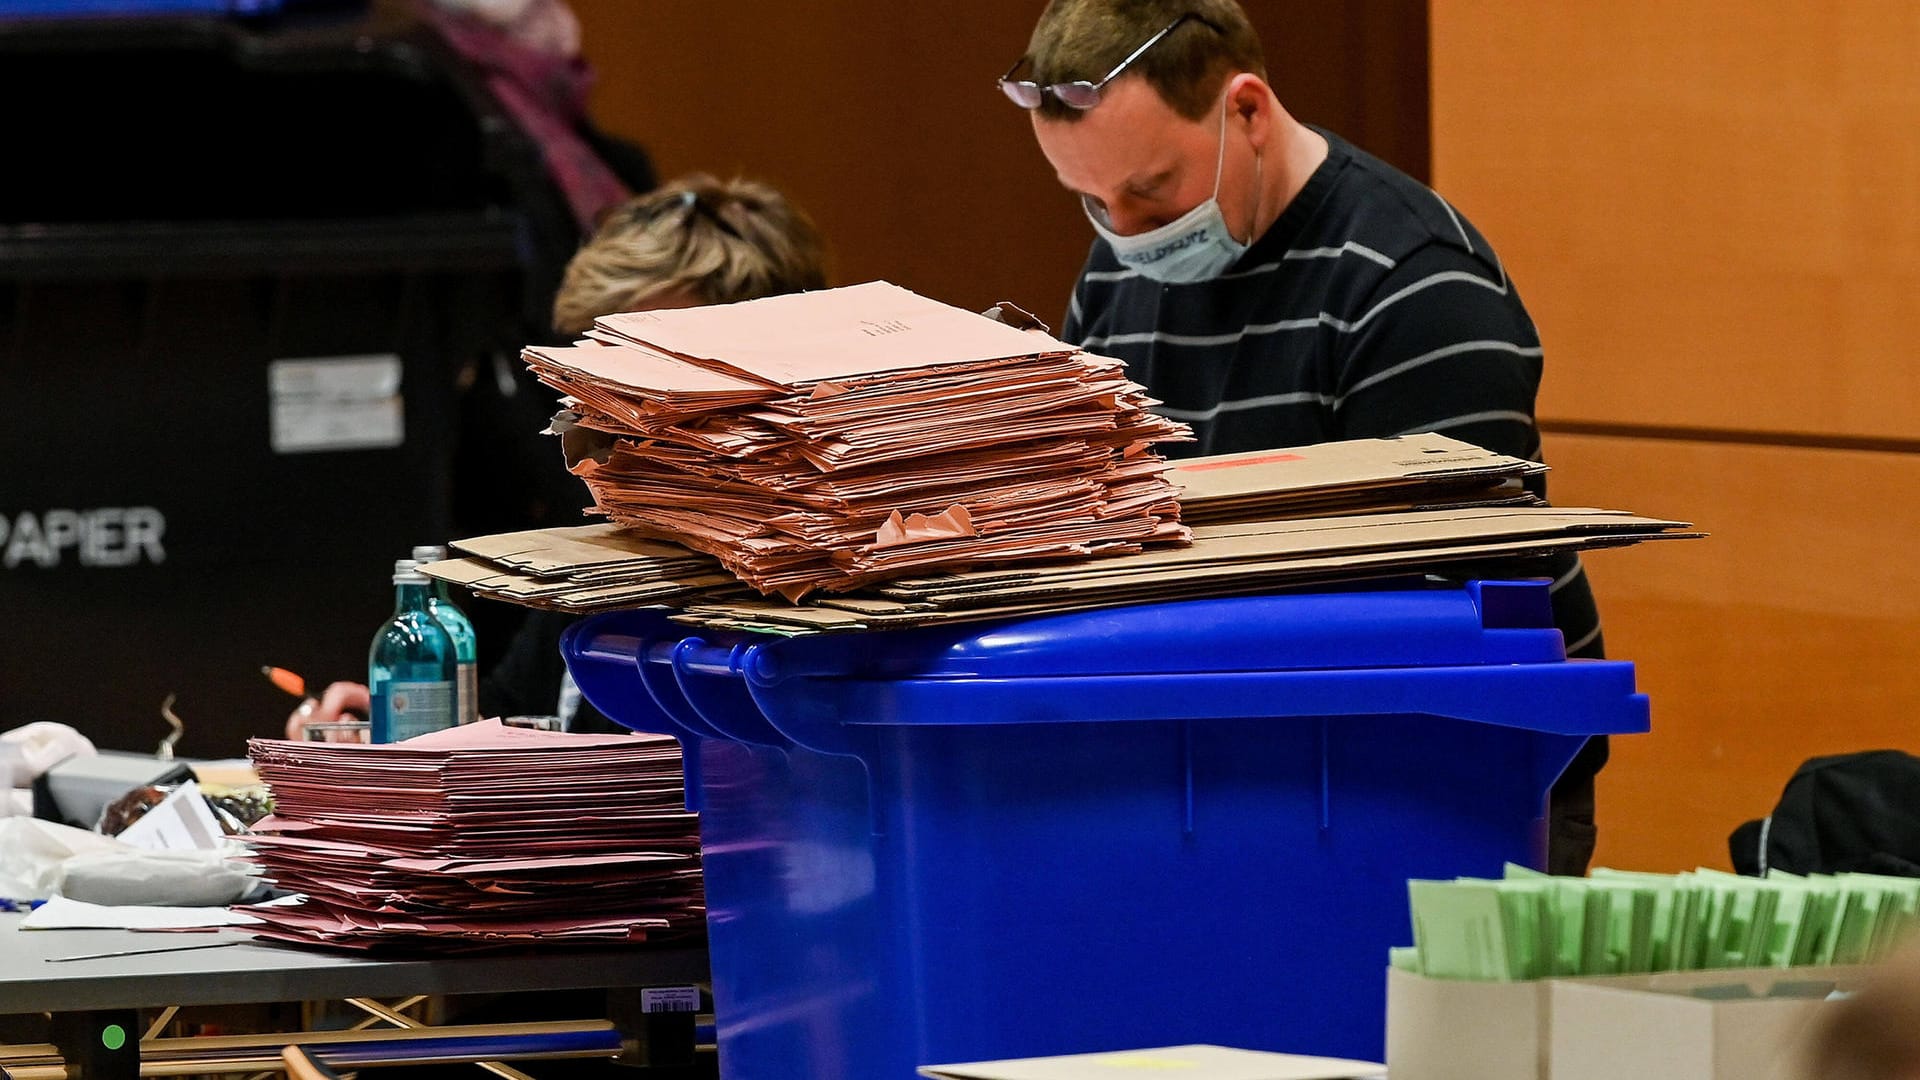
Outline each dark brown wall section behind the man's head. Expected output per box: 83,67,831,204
572,0,1427,323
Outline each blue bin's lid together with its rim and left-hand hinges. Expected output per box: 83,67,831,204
561,580,1647,764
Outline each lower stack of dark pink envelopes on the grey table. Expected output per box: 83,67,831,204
248,721,705,953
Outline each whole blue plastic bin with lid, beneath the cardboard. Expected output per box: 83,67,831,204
563,582,1647,1080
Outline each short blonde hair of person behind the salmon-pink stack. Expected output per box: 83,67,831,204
553,173,828,334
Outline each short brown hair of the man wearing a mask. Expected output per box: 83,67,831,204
1016,0,1267,121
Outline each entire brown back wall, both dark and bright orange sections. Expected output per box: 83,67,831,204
574,0,1920,871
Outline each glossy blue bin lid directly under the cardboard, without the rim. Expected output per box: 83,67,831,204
741,580,1567,684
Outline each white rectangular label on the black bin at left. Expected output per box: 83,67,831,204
267,352,407,454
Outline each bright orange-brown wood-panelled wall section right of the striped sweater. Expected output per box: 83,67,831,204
1430,0,1920,871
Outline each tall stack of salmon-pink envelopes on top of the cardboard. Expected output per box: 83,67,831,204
524,282,1190,600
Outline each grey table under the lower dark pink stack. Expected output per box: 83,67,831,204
0,915,707,1080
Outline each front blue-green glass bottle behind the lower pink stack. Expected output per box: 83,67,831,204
367,559,459,742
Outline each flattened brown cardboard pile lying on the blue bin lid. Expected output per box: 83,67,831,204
426,434,1699,634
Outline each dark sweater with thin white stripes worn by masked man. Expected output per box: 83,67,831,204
1062,129,1601,657
